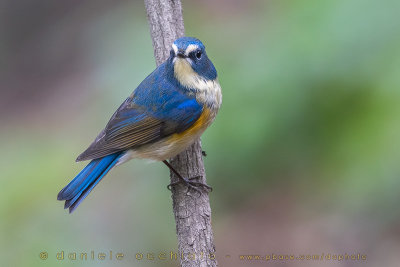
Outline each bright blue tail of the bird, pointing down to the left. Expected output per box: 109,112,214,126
57,153,122,213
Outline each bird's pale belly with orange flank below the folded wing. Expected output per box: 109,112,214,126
118,108,216,164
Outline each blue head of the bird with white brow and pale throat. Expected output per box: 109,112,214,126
169,37,217,87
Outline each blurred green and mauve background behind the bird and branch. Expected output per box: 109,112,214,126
0,0,400,266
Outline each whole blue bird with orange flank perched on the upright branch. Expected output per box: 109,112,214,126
57,37,222,213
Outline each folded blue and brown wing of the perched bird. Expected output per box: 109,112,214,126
77,69,203,161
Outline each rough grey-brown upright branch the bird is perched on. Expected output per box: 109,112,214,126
144,0,217,267
